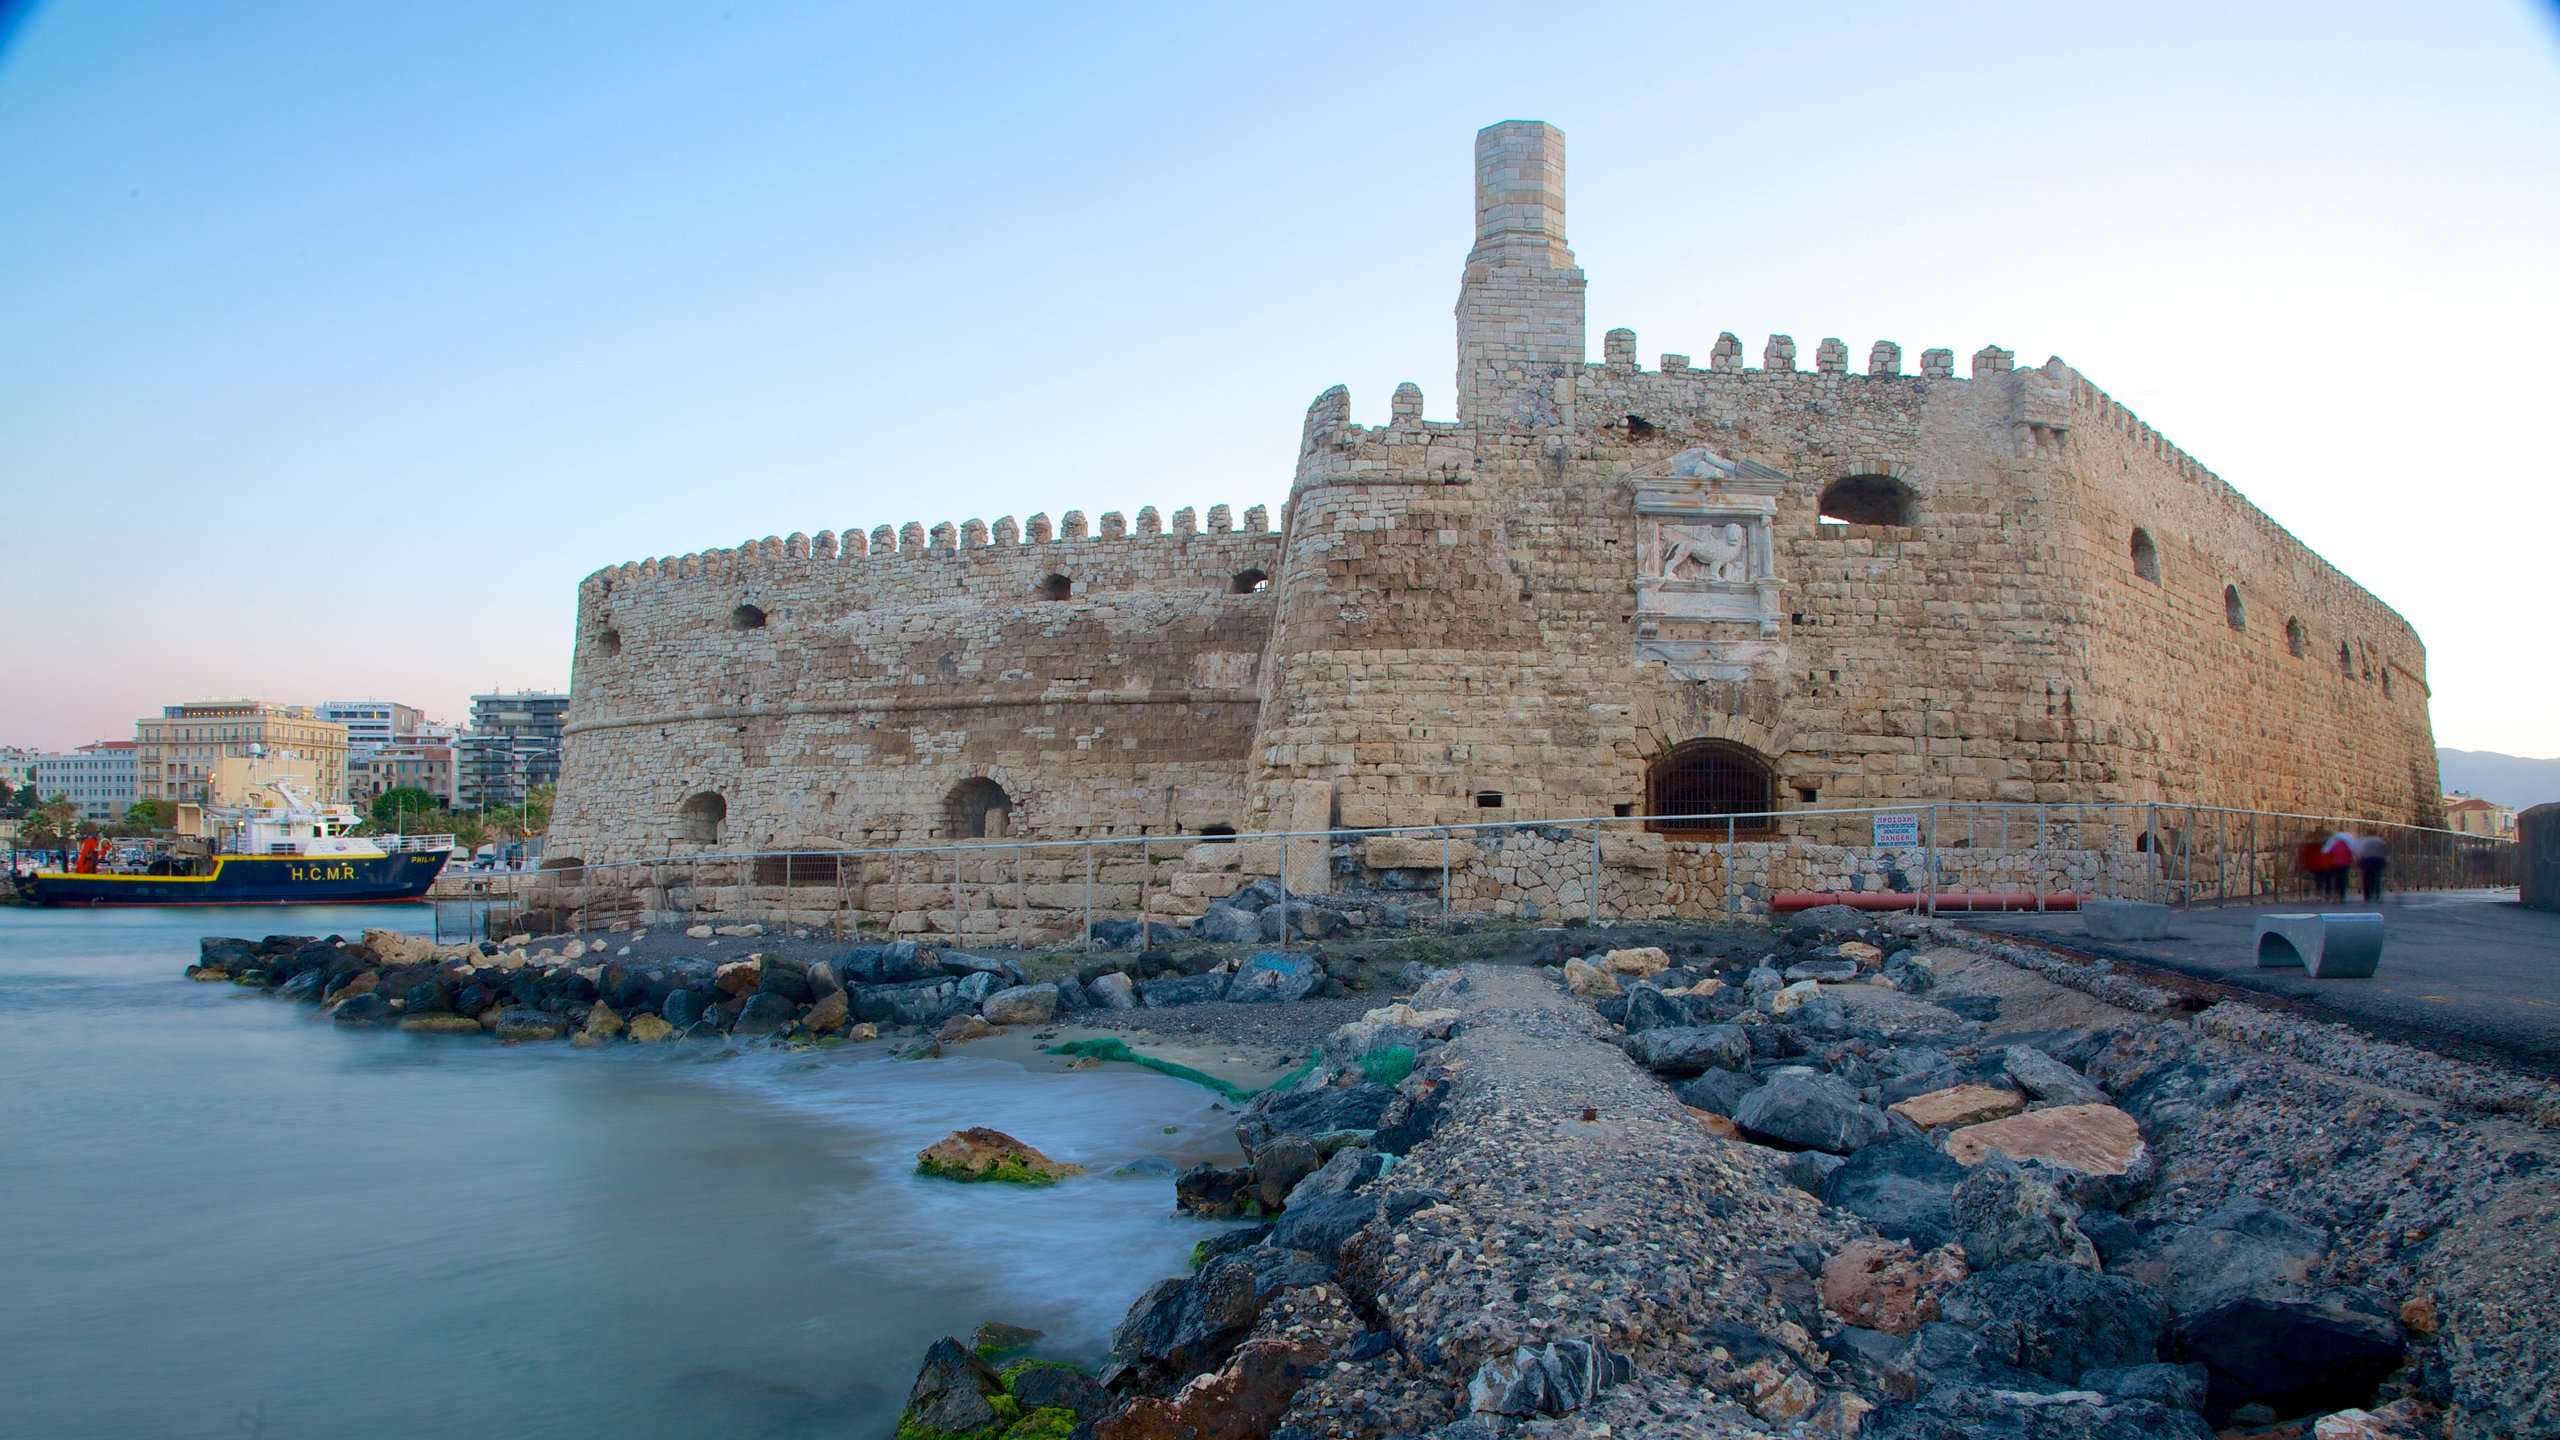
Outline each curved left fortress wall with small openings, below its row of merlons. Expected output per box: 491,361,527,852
553,510,1280,861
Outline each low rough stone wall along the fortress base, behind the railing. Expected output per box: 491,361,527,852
509,822,2284,945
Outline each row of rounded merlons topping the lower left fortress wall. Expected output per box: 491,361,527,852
581,505,1277,589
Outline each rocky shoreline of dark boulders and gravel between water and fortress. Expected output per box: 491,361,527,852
192,912,2560,1440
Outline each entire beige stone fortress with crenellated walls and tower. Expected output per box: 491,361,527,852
550,120,2442,930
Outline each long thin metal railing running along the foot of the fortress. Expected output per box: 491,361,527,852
479,802,2516,948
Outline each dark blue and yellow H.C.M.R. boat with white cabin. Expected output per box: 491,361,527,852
18,781,453,904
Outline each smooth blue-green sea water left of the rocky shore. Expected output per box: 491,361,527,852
0,907,1234,1440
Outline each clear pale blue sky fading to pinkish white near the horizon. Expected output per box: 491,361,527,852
0,0,2560,756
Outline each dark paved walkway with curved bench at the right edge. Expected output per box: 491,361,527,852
1951,889,2560,1076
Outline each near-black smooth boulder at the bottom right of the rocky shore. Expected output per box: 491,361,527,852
2176,1289,2401,1420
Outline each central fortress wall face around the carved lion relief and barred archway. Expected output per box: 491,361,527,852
1265,353,2071,822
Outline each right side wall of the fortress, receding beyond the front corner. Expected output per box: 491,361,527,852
2051,364,2442,825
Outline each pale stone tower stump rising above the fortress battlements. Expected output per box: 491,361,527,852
1457,120,1585,425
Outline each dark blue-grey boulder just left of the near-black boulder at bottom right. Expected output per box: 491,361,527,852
1938,1263,2168,1384
